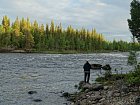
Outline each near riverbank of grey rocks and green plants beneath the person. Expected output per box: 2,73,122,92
65,65,140,105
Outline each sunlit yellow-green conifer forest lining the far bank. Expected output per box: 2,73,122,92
0,16,140,52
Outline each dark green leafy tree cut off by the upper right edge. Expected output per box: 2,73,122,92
127,0,140,42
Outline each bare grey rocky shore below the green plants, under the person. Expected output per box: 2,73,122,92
63,80,140,105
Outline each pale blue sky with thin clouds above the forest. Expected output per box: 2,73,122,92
0,0,132,41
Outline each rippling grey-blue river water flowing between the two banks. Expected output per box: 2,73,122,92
0,53,135,105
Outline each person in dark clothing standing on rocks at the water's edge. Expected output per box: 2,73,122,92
83,61,91,83
